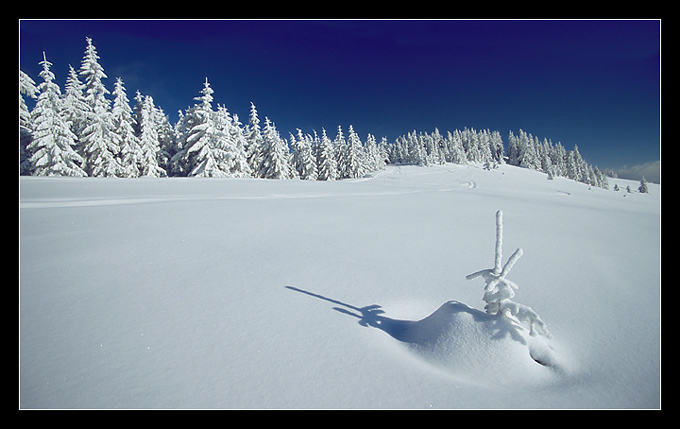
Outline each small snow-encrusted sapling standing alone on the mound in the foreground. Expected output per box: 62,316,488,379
466,210,552,338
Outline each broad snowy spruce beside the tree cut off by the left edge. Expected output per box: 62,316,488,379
26,53,87,177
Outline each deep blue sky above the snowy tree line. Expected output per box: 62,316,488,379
19,20,661,175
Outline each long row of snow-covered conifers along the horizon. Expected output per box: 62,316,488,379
19,38,608,188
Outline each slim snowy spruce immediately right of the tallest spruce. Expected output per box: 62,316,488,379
111,78,141,177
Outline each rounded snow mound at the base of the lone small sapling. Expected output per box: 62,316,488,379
372,301,565,385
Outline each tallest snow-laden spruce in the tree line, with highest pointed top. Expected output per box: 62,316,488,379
80,37,121,177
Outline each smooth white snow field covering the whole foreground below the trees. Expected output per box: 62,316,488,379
19,164,661,409
